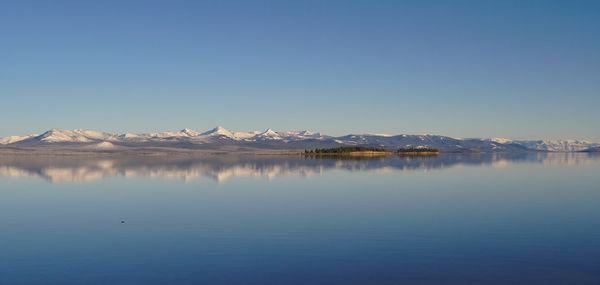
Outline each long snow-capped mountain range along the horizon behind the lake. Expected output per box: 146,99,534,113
0,127,600,152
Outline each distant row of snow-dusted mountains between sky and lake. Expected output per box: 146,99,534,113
0,126,600,152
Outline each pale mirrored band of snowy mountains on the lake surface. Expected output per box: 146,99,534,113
0,152,599,183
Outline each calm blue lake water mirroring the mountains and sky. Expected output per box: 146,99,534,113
0,154,600,284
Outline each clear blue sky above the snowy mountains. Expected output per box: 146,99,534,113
0,0,600,141
